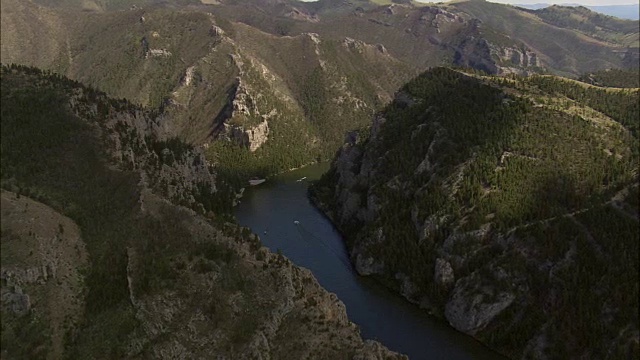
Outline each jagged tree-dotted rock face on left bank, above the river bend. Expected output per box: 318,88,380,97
69,85,217,211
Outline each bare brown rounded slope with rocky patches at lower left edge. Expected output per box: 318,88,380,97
0,189,87,358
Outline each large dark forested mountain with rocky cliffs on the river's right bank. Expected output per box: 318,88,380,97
312,68,640,359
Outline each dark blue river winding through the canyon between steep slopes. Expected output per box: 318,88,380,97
235,163,504,360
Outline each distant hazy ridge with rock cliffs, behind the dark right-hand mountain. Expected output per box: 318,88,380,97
212,0,638,74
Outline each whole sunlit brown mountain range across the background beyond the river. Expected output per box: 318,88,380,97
0,0,639,187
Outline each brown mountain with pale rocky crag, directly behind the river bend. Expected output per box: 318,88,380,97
2,1,416,183
